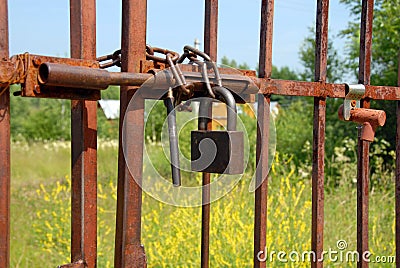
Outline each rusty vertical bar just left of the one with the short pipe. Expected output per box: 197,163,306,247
311,0,329,268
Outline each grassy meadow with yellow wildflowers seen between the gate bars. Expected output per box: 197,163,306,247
11,141,394,267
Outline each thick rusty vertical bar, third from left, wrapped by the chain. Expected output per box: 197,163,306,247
114,0,147,267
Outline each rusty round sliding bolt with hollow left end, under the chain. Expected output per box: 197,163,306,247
36,62,258,98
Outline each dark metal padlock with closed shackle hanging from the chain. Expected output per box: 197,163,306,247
191,86,244,175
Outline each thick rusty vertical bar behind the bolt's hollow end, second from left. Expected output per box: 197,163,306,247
70,0,97,267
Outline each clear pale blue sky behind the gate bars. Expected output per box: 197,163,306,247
9,0,349,70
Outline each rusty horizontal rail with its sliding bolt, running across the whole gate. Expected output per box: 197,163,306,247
0,59,400,100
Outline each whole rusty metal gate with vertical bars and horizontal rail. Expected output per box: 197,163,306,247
0,0,400,267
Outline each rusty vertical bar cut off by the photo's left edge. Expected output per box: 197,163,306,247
0,0,11,268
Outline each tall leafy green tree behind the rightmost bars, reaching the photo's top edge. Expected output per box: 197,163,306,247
340,0,400,156
